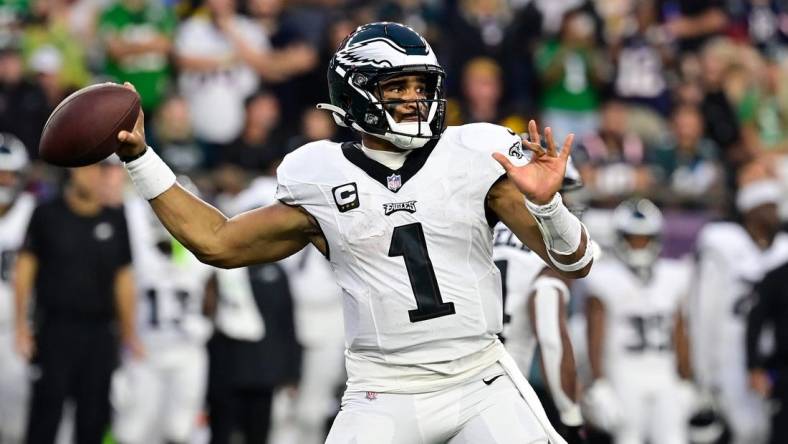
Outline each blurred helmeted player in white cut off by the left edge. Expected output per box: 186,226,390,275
0,133,35,443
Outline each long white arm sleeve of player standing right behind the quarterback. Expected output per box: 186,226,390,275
533,276,583,426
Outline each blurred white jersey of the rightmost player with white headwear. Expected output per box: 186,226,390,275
690,222,788,389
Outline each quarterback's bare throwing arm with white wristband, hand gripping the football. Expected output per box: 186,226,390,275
117,83,318,268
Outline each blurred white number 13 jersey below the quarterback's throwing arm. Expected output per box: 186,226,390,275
126,198,213,348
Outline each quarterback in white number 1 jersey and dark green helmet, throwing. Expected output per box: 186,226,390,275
118,22,593,444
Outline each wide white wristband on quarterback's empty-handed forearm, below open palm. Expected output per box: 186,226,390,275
525,193,583,256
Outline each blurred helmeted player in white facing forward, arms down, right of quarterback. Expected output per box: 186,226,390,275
584,199,692,444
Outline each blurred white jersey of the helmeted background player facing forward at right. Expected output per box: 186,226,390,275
584,257,692,381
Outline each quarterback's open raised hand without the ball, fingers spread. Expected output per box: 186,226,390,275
493,120,575,205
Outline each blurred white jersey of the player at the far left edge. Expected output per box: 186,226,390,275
0,193,36,331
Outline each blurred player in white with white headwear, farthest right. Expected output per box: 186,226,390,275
690,180,788,444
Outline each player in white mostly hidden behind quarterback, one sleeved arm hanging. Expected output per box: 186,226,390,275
493,164,583,443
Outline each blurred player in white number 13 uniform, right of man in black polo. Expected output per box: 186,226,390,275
112,198,212,444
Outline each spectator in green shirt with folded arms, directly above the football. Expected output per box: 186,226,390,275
99,0,176,111
